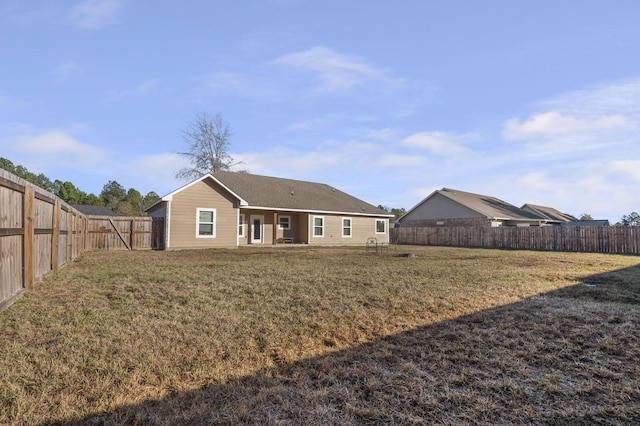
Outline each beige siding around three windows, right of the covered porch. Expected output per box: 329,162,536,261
308,214,389,245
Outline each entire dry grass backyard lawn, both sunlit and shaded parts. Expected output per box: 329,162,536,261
0,246,640,425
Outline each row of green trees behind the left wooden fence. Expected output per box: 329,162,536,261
0,157,160,216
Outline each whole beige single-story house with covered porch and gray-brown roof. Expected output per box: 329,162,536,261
145,172,393,249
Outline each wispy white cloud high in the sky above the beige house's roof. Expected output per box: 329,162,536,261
273,46,397,93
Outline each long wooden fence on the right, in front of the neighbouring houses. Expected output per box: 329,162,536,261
391,226,640,254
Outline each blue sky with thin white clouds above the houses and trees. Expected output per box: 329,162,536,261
0,0,640,223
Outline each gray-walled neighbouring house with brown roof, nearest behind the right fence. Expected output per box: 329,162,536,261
397,188,560,227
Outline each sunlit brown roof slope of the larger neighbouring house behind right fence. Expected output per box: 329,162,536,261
437,188,541,220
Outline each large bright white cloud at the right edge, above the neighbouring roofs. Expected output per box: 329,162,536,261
496,76,640,171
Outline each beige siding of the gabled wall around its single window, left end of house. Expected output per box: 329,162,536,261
169,179,238,249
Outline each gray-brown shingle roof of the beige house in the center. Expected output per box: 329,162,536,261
213,172,389,216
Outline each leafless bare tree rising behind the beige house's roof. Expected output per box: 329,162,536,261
176,112,241,180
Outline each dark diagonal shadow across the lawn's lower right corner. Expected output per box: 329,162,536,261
46,267,640,424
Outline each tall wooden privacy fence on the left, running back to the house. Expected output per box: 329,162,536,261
0,170,158,311
